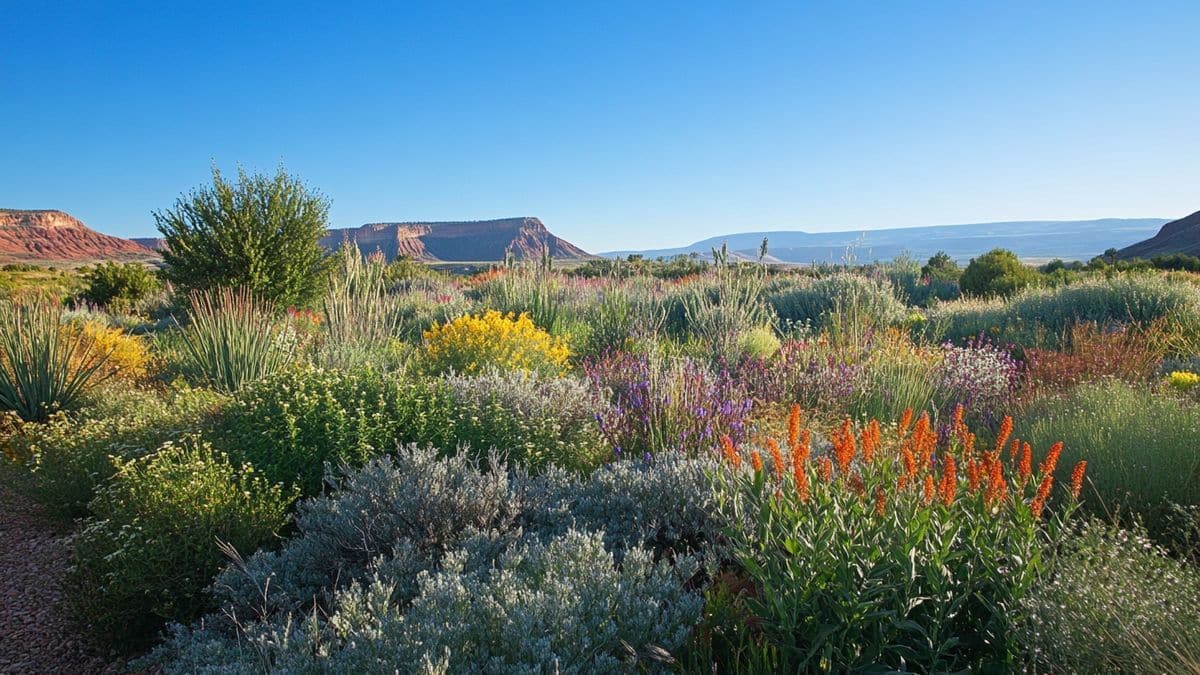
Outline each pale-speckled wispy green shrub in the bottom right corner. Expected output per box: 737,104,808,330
1022,522,1200,673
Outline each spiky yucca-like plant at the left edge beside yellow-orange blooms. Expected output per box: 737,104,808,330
0,297,109,422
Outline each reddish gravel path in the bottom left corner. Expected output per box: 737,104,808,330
0,485,121,674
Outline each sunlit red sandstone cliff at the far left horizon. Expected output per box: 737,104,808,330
0,209,157,263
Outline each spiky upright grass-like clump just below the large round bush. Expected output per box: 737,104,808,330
178,288,294,392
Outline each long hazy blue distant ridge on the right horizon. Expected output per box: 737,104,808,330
600,219,1166,263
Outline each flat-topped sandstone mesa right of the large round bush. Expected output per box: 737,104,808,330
322,217,592,262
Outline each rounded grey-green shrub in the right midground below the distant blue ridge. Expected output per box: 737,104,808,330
768,273,905,329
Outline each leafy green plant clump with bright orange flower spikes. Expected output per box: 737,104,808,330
698,401,1085,673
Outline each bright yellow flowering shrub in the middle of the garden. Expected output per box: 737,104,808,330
424,310,570,375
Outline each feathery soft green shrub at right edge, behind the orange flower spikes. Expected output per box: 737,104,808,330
1024,380,1200,543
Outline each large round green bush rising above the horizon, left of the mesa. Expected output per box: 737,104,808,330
154,167,329,306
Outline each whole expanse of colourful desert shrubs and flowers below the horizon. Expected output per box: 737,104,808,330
0,172,1200,673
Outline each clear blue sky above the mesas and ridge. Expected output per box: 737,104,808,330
0,0,1200,251
